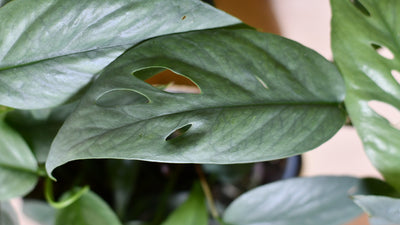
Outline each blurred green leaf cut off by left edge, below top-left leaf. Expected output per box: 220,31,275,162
0,112,38,201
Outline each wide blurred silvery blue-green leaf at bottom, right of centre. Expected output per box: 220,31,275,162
223,177,368,225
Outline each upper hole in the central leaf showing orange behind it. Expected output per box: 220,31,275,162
145,70,201,94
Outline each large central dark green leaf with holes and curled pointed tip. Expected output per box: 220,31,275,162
46,27,344,176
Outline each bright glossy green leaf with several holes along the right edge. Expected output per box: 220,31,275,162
331,0,400,190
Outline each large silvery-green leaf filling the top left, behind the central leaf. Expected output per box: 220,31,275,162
0,0,239,109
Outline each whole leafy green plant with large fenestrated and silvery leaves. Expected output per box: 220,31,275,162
0,0,400,225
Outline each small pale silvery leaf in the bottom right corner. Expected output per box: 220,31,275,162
354,195,400,225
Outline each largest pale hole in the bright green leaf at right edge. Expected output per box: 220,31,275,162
368,100,400,129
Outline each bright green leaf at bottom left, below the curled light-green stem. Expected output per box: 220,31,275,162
55,191,121,225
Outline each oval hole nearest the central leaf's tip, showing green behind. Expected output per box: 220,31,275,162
96,89,150,107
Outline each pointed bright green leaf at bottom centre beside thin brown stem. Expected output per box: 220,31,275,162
162,184,208,225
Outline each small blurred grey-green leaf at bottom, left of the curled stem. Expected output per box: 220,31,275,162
22,200,56,225
